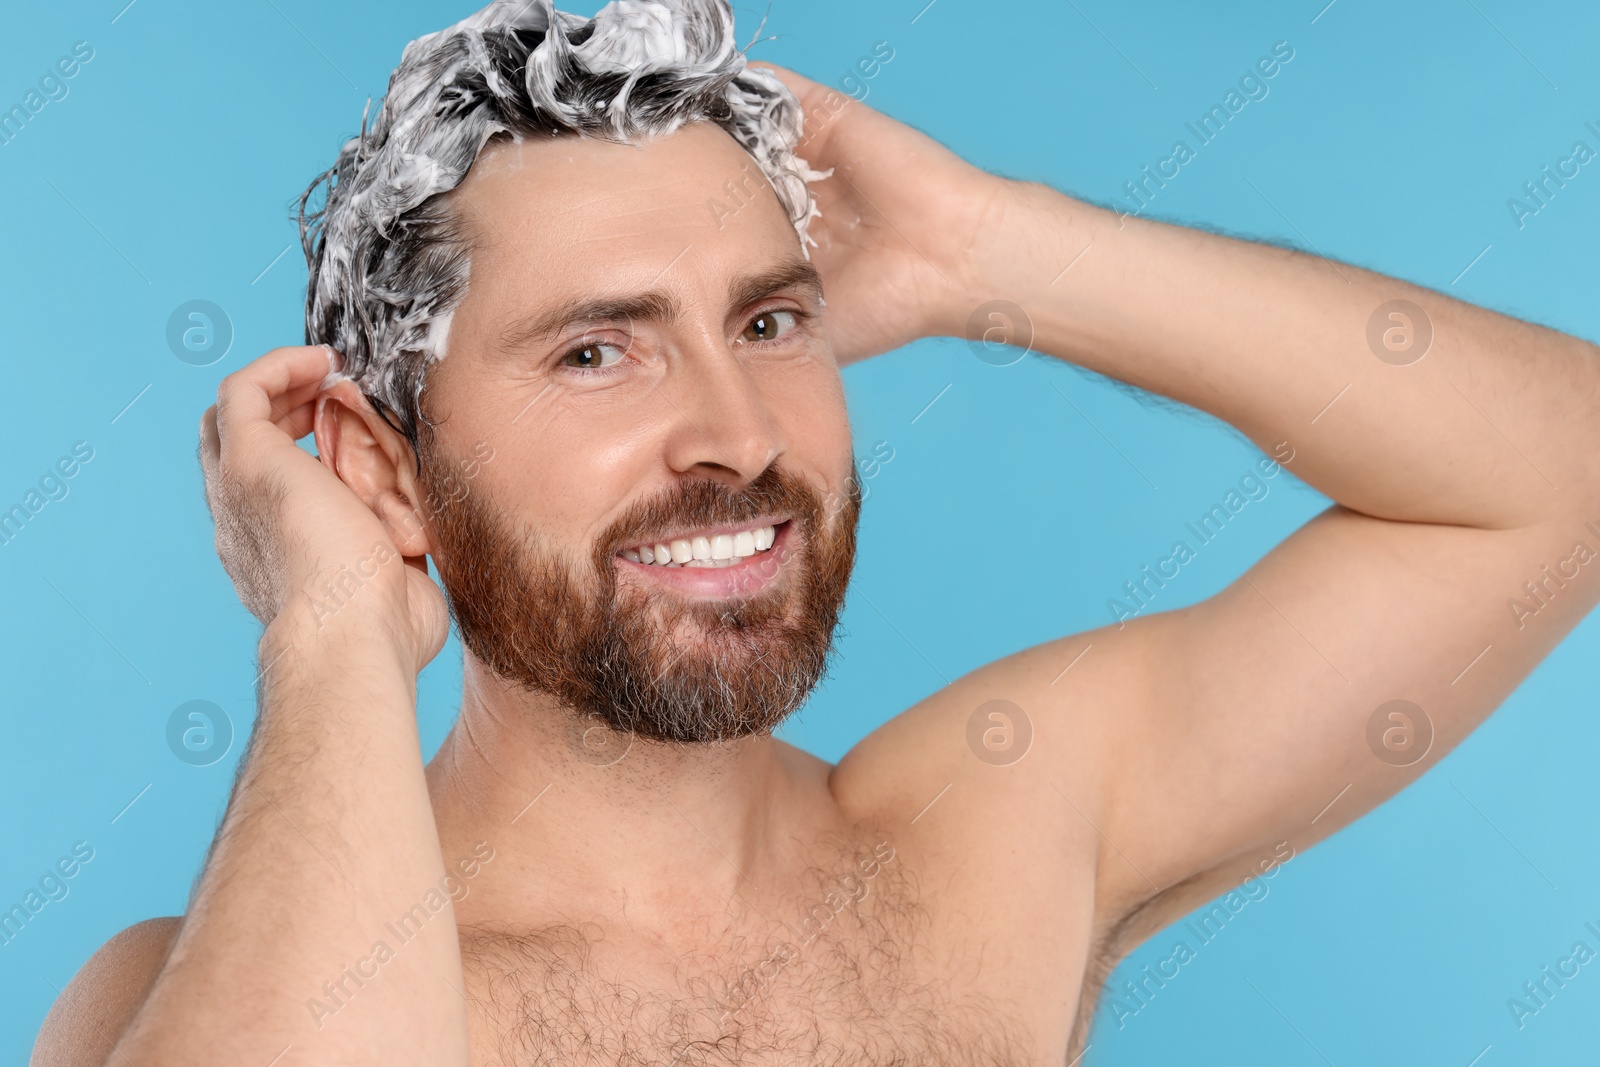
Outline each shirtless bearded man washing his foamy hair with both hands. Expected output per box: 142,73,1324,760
35,0,1600,1067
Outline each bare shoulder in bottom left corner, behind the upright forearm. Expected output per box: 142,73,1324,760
29,915,182,1067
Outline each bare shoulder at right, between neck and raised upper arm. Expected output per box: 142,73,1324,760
830,619,1158,904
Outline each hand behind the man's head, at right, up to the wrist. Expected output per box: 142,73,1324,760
750,62,1006,366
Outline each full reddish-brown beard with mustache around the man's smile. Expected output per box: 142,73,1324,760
418,426,861,742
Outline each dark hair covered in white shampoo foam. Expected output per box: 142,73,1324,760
299,0,827,450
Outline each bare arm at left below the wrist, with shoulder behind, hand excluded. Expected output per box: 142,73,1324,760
34,619,467,1067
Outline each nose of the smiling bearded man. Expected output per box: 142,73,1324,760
658,329,787,485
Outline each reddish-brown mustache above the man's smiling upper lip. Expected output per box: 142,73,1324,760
595,464,822,569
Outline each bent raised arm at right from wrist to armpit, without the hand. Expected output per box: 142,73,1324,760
939,182,1600,928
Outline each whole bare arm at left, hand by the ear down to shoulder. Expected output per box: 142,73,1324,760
34,349,469,1067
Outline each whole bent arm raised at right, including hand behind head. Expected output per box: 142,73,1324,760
758,64,1600,958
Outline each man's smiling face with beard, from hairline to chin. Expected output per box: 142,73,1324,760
421,123,859,742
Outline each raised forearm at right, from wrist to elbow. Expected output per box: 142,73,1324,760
939,184,1600,530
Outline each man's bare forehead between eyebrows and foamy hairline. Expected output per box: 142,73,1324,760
453,122,798,299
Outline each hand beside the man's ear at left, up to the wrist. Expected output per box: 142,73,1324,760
200,346,450,670
